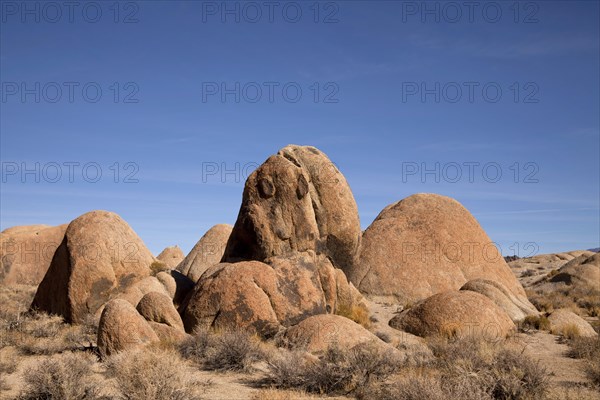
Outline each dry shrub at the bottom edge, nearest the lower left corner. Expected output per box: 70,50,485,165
20,352,99,400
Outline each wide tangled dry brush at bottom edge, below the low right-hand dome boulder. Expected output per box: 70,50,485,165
372,336,549,400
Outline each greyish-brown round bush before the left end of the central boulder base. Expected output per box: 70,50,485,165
180,329,266,371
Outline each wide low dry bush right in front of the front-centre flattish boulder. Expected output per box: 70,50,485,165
267,343,401,394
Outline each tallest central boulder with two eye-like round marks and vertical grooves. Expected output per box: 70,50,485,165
223,145,361,268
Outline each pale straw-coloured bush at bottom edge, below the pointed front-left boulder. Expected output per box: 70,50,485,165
106,347,210,400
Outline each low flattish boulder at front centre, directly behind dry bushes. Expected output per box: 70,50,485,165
283,314,393,355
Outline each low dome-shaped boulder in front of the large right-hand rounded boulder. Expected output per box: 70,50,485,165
390,290,515,340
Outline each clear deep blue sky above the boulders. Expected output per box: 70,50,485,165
0,1,600,255
